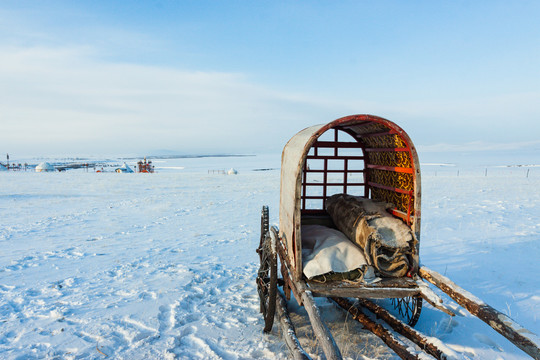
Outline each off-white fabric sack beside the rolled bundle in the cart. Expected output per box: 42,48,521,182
302,225,367,279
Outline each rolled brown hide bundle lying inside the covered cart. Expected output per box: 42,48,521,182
326,194,416,277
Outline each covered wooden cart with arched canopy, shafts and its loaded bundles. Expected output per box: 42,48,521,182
257,115,540,359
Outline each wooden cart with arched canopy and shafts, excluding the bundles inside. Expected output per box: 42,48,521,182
257,115,540,359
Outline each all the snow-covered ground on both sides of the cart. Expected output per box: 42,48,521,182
0,154,540,359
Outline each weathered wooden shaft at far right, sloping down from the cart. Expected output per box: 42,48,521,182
419,266,540,360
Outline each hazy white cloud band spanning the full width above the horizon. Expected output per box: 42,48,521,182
0,42,540,155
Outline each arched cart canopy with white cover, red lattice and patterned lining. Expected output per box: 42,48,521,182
279,115,421,279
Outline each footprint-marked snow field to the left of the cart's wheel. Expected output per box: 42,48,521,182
0,173,285,359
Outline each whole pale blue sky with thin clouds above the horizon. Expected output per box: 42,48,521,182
0,1,540,159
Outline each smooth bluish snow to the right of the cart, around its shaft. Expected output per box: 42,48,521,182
417,173,540,359
